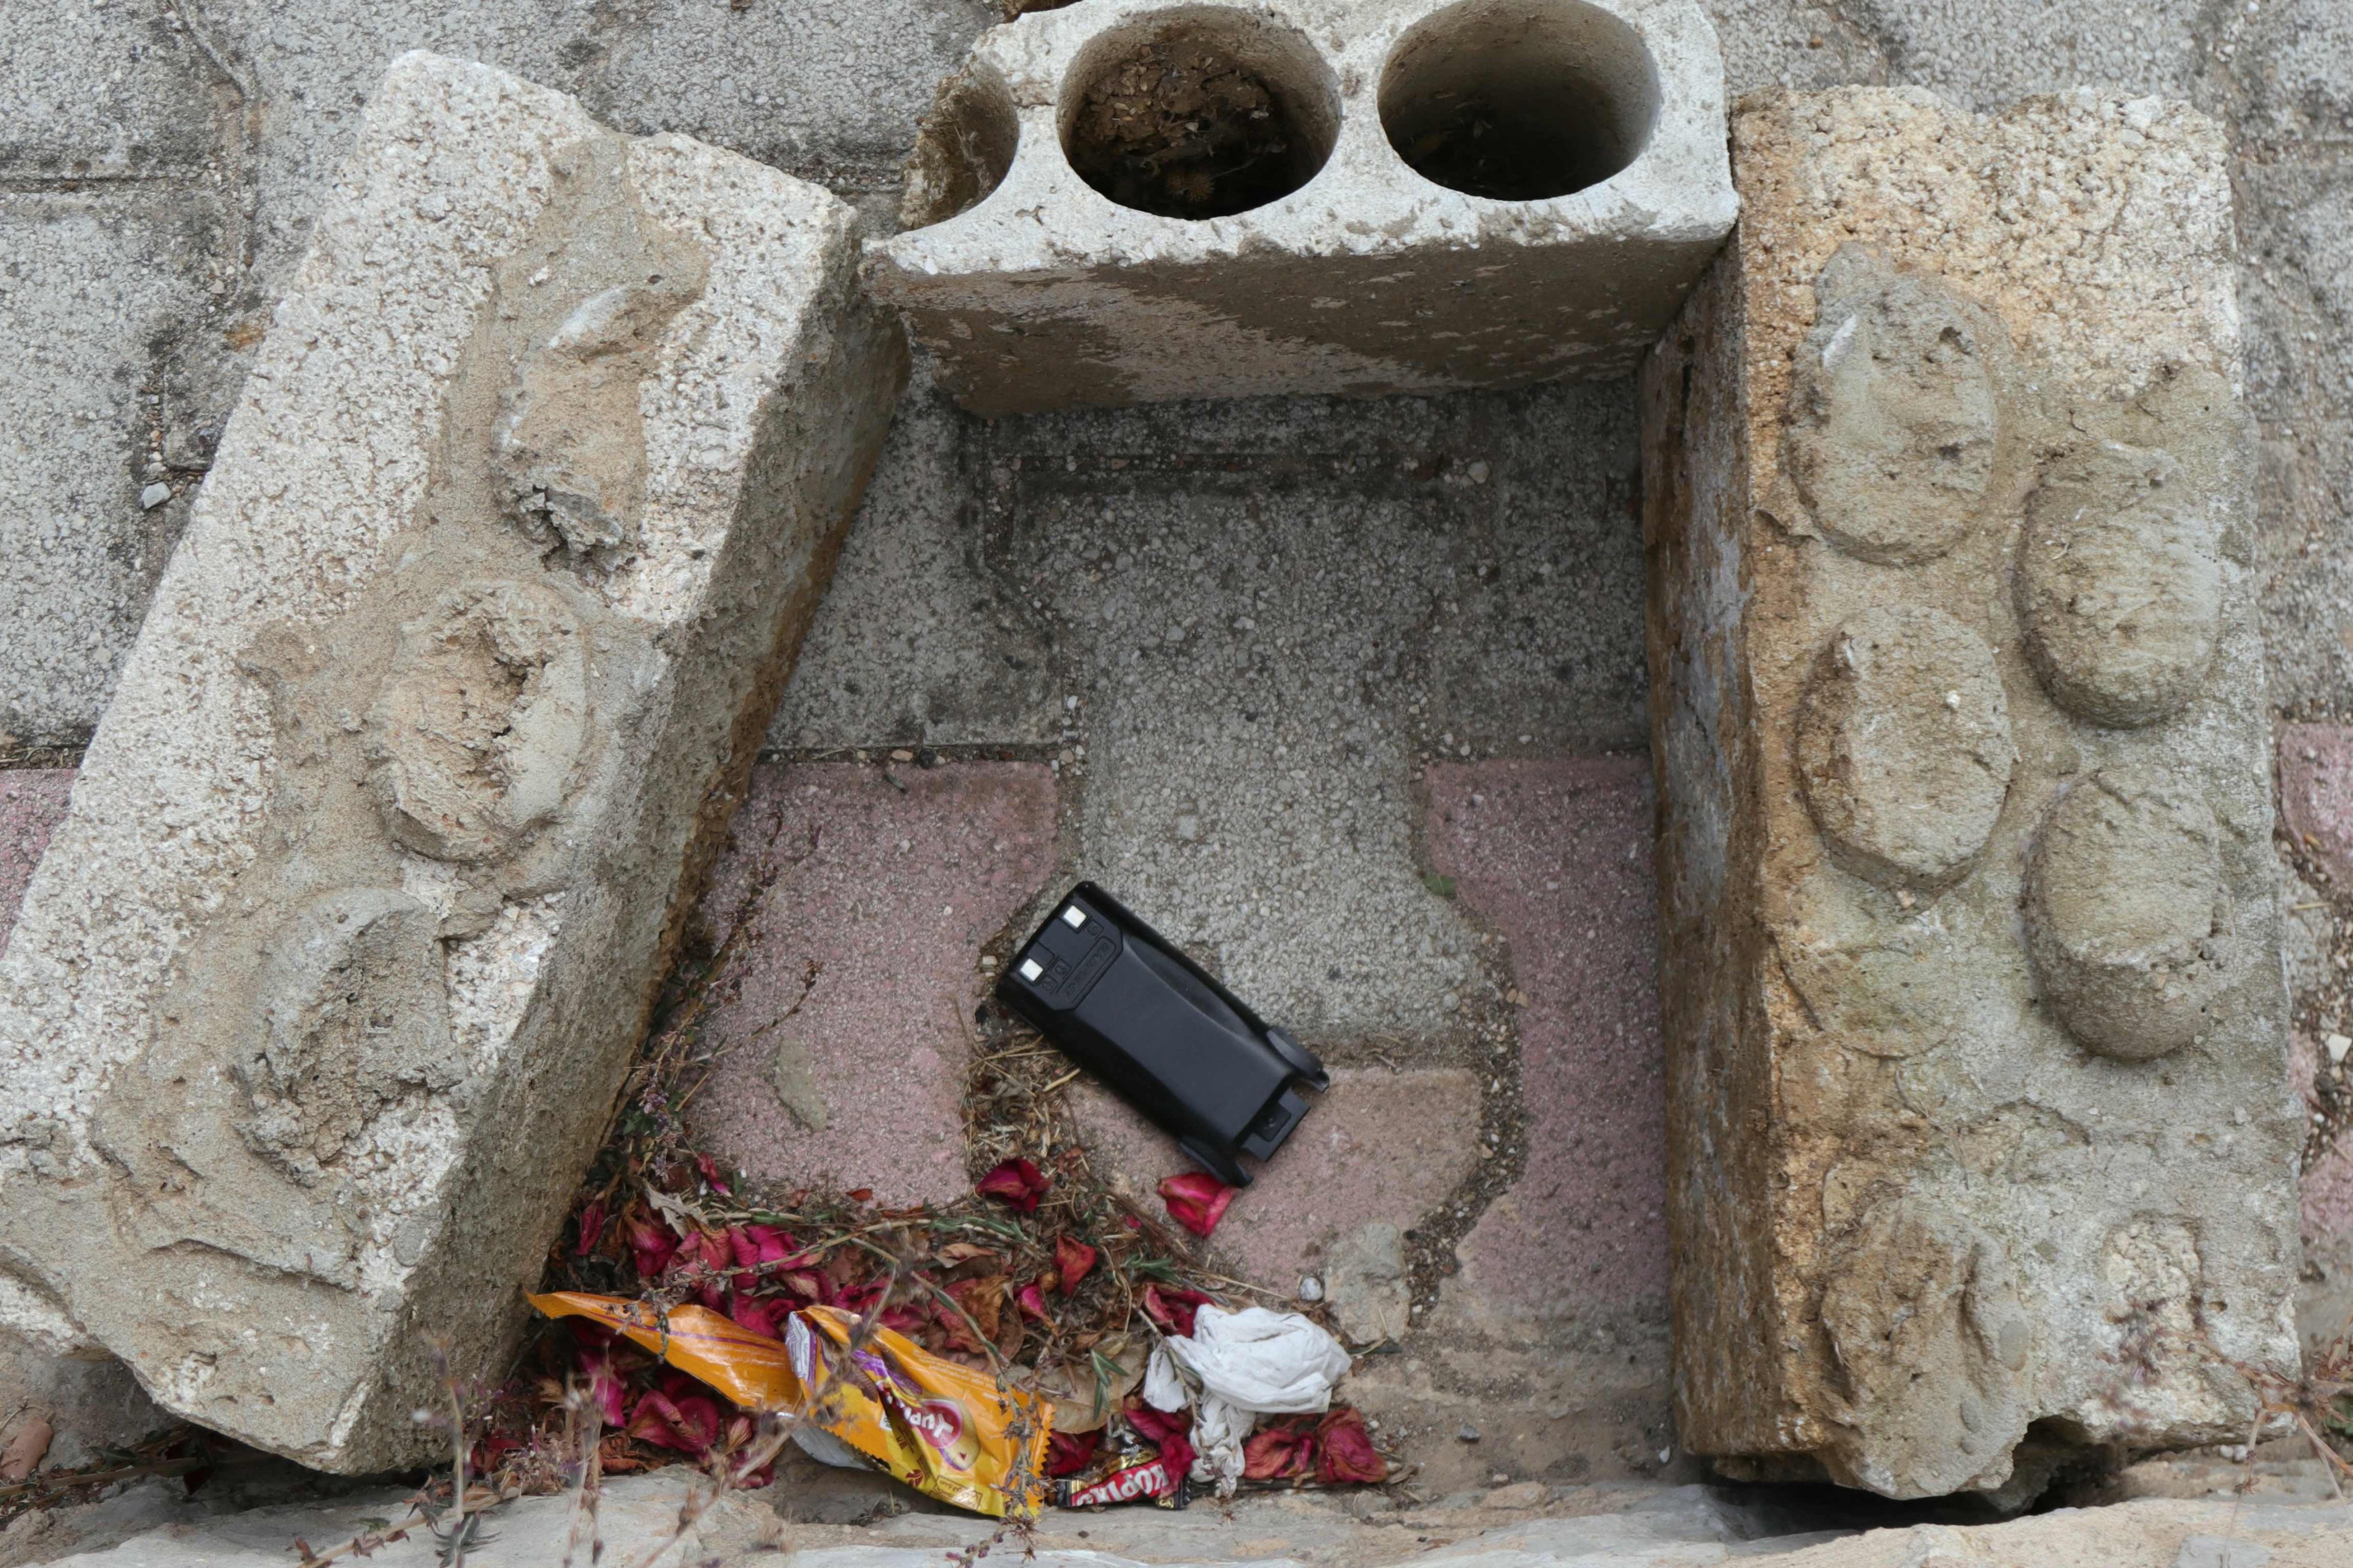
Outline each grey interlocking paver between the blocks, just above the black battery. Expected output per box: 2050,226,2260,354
974,385,1642,1051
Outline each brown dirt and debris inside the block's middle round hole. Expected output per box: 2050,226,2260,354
1066,37,1322,219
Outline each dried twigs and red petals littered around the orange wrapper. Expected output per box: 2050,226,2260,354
470,926,1393,1523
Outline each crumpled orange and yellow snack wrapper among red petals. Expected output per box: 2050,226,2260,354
530,1291,1054,1519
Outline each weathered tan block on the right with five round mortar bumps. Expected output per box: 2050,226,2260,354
1642,90,2299,1495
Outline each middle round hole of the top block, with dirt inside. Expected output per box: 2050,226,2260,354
1061,7,1339,219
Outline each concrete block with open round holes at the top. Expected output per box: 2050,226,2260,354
873,0,1734,414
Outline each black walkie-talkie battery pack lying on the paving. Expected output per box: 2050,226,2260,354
998,882,1332,1187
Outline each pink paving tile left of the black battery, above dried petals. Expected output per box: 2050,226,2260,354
689,762,1056,1204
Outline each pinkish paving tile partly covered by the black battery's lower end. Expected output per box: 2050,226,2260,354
1071,1067,1480,1288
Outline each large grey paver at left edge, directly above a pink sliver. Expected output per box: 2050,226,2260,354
0,188,217,745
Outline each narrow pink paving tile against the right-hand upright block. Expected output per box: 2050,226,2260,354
1428,757,1666,1312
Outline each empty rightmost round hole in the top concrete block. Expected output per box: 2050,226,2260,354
1381,0,1659,202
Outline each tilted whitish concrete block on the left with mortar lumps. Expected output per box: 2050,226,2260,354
0,54,906,1472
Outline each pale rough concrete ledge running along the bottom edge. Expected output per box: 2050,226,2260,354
26,1469,2353,1568
